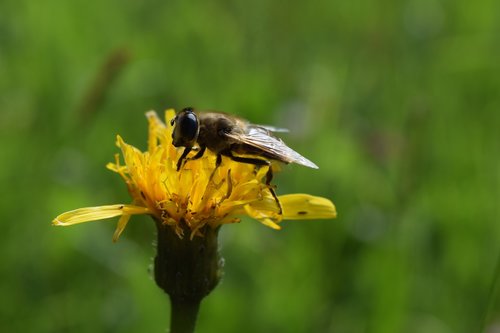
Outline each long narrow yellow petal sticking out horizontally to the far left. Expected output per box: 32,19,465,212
52,205,151,226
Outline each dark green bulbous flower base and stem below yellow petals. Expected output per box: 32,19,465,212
154,221,222,333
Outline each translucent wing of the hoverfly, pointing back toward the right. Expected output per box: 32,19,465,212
226,125,318,169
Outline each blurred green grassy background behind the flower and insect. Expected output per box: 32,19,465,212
0,0,500,333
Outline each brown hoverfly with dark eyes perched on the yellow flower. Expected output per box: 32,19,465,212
170,107,318,213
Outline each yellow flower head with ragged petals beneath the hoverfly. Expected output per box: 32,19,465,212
52,109,337,241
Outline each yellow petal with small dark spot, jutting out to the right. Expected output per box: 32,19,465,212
278,193,337,220
